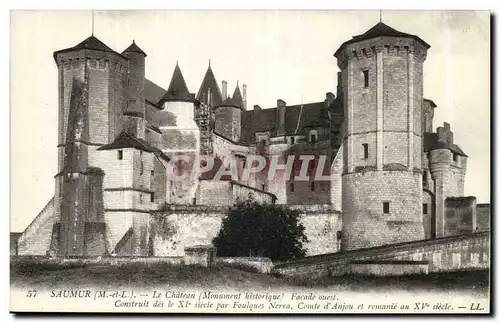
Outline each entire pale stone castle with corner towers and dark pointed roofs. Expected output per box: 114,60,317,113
11,23,488,257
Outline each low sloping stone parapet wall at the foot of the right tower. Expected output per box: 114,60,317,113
273,232,490,278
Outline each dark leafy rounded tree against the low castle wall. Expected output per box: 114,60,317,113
213,201,307,260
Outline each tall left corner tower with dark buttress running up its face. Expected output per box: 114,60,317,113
53,35,128,256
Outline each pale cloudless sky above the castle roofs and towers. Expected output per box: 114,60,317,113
10,11,490,231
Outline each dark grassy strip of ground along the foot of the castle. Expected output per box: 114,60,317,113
11,263,489,294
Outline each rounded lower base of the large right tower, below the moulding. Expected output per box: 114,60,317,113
342,171,424,250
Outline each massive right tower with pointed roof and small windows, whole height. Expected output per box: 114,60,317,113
335,23,430,250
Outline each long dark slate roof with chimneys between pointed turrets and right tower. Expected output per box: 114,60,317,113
241,101,341,144
